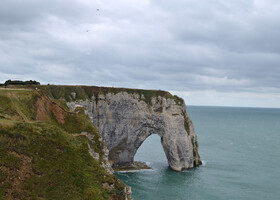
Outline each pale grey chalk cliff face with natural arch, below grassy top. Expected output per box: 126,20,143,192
67,91,201,171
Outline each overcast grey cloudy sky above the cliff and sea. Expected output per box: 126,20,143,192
0,0,280,108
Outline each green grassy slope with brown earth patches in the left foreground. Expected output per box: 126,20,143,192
0,90,125,199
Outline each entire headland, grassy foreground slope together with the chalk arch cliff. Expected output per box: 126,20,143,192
0,85,201,200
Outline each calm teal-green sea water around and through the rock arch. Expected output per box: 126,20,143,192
116,106,280,200
